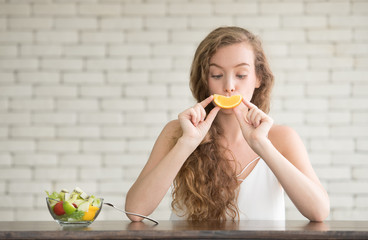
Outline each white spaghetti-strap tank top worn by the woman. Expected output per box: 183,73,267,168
170,158,285,220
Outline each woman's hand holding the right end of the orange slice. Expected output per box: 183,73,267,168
233,98,273,148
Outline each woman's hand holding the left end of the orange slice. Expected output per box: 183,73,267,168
178,95,220,147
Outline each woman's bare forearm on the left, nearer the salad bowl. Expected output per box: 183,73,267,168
125,138,194,220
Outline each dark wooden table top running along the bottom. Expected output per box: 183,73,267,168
0,221,368,239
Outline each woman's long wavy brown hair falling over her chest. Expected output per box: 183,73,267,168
171,27,274,220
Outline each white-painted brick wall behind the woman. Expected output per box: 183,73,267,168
0,0,368,220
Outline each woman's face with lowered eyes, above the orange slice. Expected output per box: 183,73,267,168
208,43,260,104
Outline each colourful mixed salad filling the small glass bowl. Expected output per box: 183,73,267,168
46,187,101,222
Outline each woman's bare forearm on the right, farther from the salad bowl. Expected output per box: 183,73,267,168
255,139,330,221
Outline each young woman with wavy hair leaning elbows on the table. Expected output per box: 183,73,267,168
125,27,329,221
